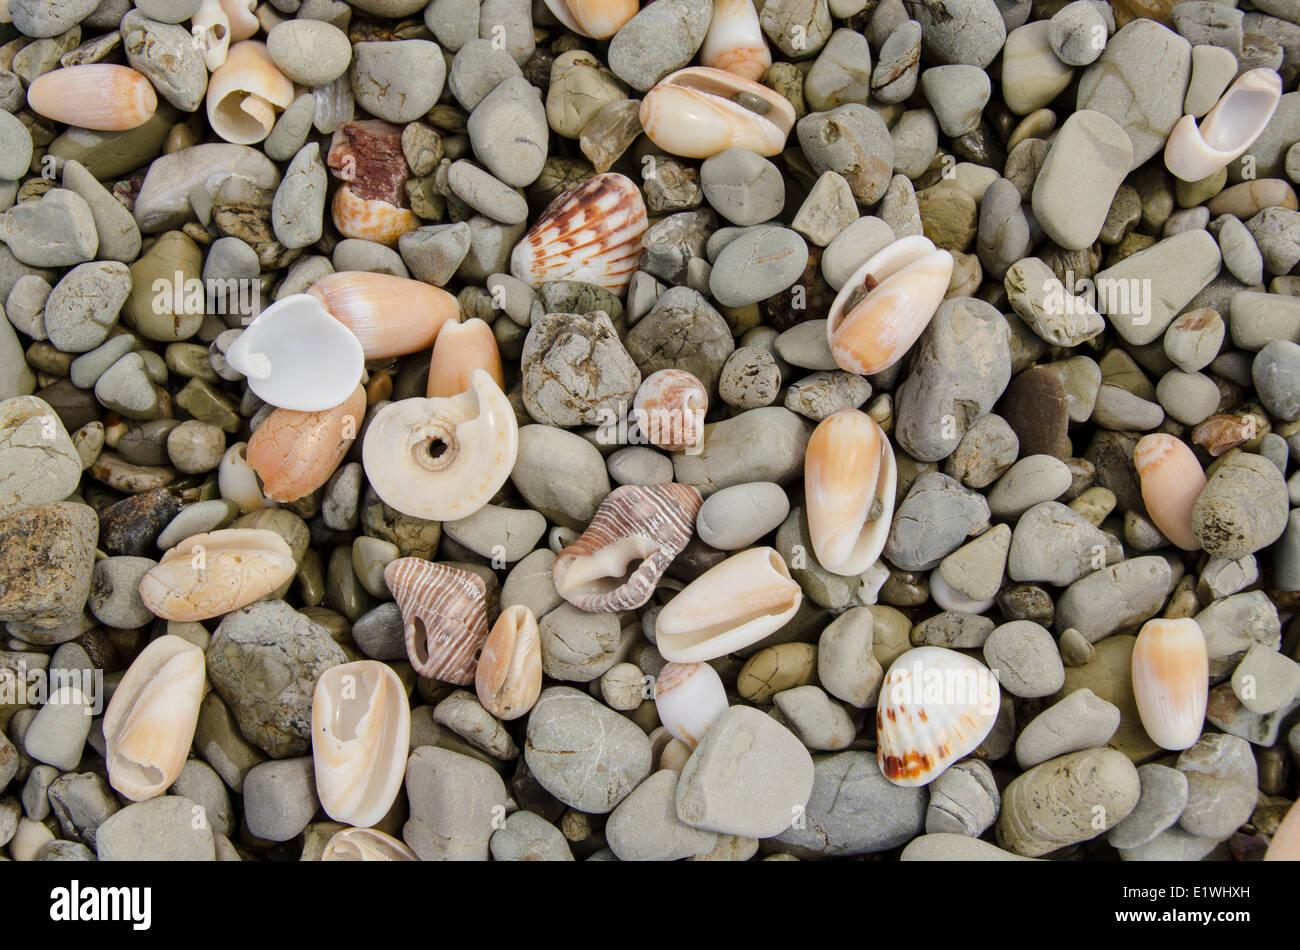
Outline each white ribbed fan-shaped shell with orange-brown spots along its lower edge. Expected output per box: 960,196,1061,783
876,646,1001,788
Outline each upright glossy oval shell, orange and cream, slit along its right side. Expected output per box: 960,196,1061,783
803,409,898,577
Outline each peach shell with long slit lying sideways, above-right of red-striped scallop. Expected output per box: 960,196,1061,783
641,66,794,159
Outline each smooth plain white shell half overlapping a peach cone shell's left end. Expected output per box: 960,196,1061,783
226,294,365,412
